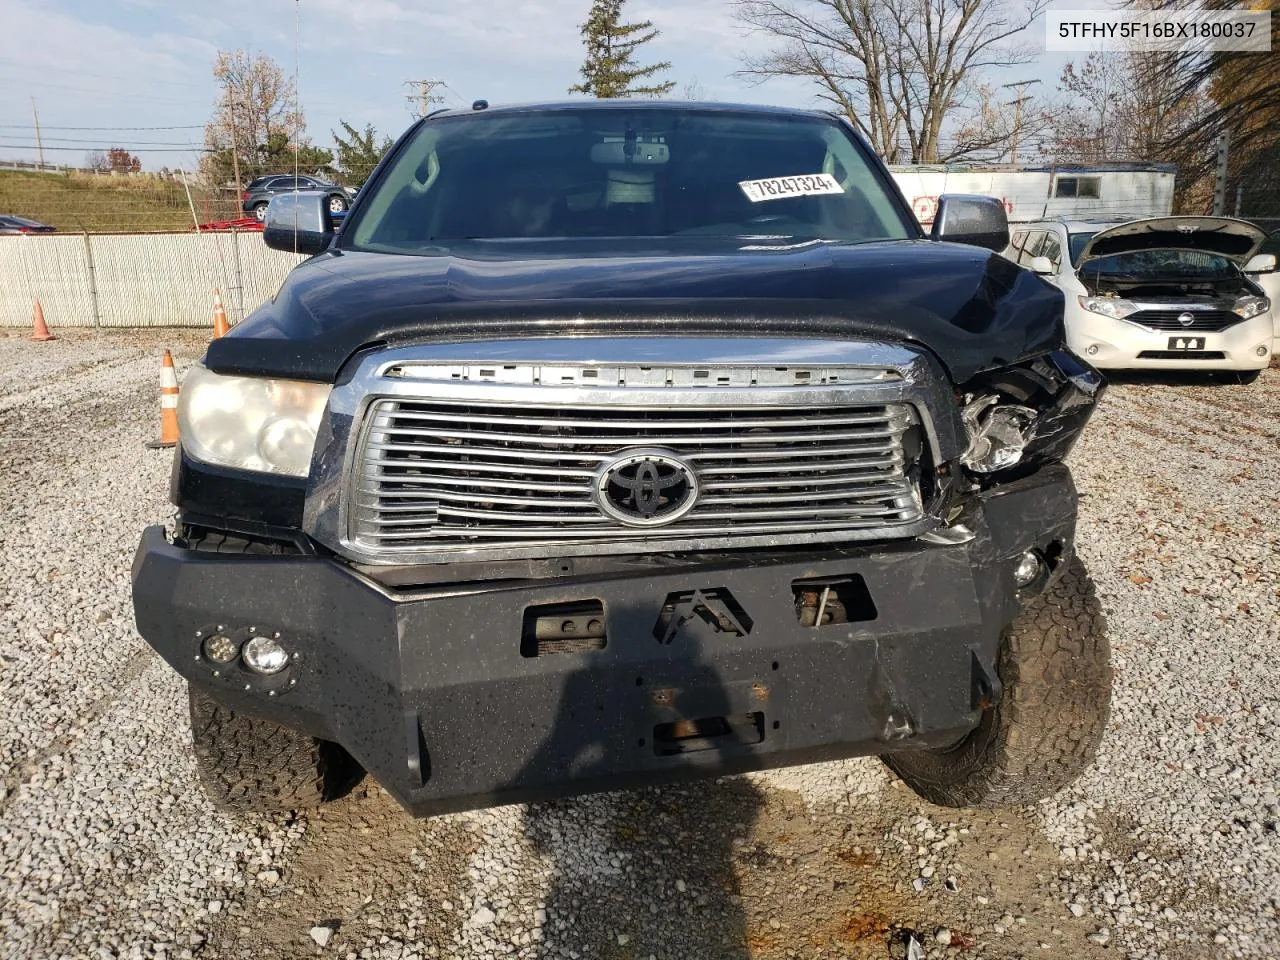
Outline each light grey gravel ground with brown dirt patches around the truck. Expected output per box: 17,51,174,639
0,330,1280,960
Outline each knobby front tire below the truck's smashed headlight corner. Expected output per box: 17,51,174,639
883,558,1111,806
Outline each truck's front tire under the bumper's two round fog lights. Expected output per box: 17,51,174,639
188,686,364,813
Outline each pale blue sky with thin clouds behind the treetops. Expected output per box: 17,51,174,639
0,0,1066,169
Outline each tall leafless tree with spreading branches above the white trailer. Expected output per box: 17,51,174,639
733,0,1047,164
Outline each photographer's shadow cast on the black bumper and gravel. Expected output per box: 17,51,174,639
521,627,767,960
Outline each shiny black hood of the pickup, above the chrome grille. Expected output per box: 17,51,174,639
206,238,1064,383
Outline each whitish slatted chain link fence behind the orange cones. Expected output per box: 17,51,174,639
0,230,302,329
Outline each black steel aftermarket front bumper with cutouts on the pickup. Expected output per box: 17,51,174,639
133,466,1075,815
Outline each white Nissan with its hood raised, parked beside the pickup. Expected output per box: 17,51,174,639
1006,216,1276,383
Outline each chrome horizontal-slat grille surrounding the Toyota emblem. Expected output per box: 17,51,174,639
348,398,923,559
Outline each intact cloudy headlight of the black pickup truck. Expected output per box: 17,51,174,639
178,366,330,476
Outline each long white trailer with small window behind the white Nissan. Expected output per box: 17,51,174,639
890,164,1175,228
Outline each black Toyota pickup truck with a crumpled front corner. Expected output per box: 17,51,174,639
133,101,1111,815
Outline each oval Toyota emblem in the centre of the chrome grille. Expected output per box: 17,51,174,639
595,449,698,526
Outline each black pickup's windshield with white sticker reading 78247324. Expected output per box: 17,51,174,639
344,106,916,253
